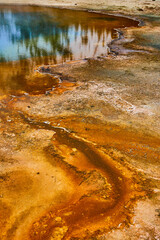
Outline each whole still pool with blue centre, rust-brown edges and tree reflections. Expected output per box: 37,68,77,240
0,6,138,95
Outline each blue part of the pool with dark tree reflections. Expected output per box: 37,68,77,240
0,10,74,61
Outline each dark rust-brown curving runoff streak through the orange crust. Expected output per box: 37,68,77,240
12,114,143,239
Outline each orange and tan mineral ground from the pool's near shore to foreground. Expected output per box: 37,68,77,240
0,3,160,240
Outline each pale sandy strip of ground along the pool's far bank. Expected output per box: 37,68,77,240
0,0,160,14
